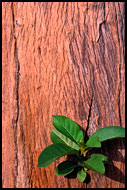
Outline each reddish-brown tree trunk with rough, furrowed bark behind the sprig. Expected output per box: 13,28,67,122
2,2,125,188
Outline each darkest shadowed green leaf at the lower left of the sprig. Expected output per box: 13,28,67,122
55,160,78,176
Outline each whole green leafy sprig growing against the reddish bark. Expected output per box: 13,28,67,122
38,115,125,182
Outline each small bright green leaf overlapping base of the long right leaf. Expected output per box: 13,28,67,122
86,136,101,147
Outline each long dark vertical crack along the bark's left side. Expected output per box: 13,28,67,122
11,2,20,188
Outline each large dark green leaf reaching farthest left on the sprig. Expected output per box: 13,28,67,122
38,143,74,167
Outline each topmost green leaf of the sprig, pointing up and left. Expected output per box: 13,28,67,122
53,115,83,144
